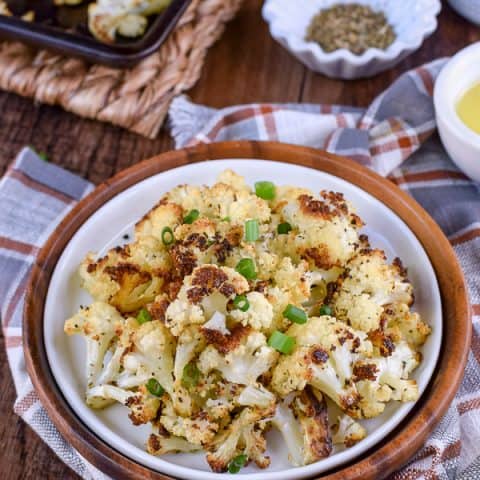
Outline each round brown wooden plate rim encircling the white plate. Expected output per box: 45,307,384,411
23,142,472,480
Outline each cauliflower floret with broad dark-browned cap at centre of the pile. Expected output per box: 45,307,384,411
165,265,249,336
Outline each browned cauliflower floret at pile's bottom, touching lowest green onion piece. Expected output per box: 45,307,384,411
207,408,273,473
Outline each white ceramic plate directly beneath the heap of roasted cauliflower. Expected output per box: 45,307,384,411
43,159,442,480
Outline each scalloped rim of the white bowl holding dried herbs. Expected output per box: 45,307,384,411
262,0,442,66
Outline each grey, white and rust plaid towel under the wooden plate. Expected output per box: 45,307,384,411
0,61,480,480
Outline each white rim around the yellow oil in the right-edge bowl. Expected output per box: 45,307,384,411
433,42,480,148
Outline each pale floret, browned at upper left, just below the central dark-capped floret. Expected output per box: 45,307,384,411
198,327,278,385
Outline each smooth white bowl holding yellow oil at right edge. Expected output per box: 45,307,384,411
433,42,480,182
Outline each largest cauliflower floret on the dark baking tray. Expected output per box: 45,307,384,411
89,0,171,43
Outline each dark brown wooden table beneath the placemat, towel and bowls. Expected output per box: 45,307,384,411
0,0,480,480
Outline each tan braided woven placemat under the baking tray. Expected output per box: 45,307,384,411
0,0,242,138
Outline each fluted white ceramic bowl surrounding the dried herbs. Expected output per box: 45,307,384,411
262,0,441,79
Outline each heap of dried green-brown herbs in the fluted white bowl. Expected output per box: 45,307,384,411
305,3,396,55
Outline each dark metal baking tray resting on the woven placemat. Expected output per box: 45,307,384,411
0,0,191,67
